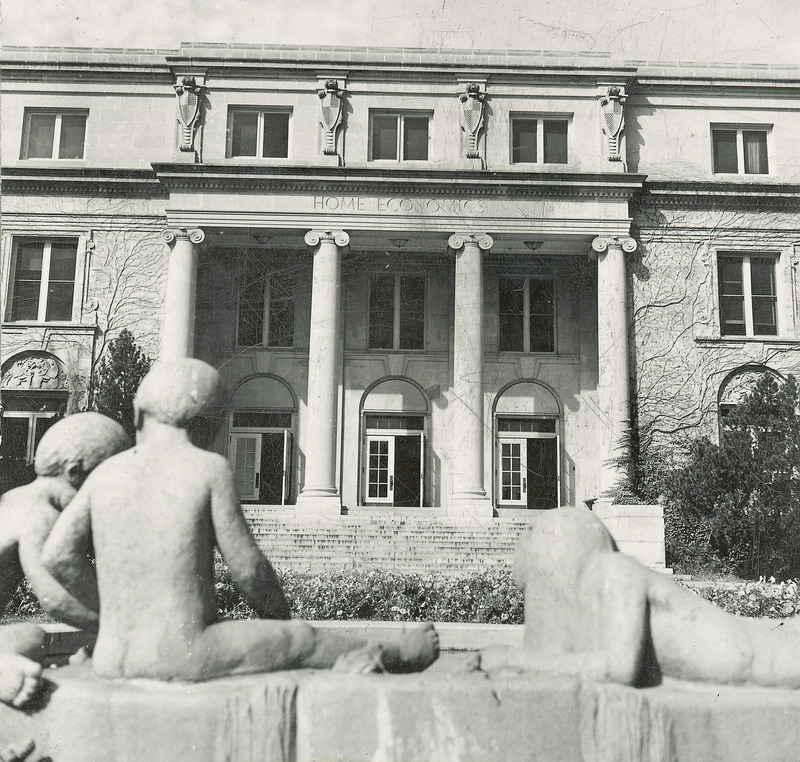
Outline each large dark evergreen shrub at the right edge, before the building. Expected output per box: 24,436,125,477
669,374,800,579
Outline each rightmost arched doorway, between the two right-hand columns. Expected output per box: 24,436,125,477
494,381,561,508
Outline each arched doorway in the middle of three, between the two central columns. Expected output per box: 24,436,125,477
361,378,429,508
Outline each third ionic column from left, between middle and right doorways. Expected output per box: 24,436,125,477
447,233,493,518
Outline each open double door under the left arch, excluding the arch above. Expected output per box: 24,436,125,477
230,429,292,505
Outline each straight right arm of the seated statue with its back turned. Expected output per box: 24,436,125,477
211,459,291,619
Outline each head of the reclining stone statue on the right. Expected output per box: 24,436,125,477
514,507,617,588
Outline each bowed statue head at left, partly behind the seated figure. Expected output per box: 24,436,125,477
34,413,131,489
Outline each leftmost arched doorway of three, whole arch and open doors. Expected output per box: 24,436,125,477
228,376,297,505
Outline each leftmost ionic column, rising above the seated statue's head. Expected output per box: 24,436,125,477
160,228,206,360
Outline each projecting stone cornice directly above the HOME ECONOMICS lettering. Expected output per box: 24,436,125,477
153,164,645,198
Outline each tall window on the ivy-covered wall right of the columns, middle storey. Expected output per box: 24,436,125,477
717,254,778,336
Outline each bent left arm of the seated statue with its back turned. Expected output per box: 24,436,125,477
39,489,100,626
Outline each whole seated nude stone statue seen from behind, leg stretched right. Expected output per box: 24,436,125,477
43,359,439,681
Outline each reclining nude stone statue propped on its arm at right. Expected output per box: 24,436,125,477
473,508,800,688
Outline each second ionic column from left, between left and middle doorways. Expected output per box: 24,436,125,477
296,230,350,515
